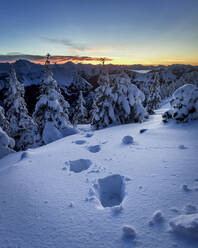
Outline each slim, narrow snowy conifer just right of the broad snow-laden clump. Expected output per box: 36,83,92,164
147,72,161,114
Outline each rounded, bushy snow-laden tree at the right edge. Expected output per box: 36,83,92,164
162,84,198,123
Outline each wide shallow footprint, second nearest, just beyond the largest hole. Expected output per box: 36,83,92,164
67,159,92,173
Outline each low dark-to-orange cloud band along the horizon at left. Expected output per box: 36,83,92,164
0,53,112,64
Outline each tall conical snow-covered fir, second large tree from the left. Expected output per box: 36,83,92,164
33,67,76,144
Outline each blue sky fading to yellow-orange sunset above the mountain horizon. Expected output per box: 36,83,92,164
0,0,198,65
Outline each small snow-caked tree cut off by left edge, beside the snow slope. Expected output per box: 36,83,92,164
0,127,15,159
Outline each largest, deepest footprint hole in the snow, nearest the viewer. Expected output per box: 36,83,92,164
98,174,125,208
